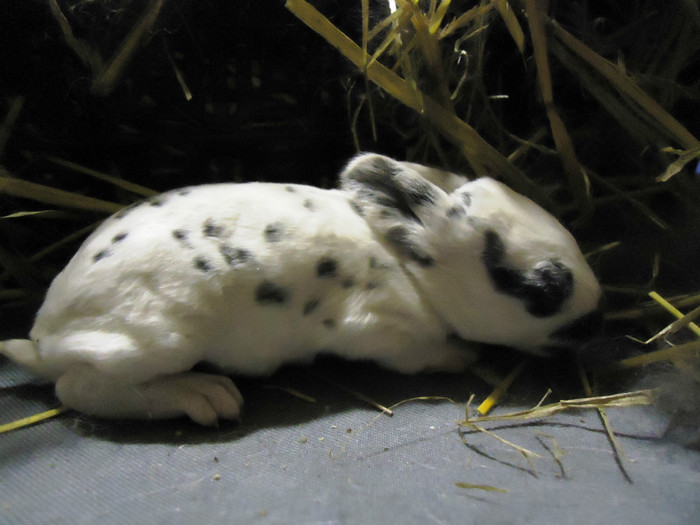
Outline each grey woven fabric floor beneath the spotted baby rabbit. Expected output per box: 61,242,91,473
0,361,700,525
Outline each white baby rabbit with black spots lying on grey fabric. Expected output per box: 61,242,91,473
0,153,601,425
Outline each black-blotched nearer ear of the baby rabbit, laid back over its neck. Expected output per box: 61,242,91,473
340,153,448,267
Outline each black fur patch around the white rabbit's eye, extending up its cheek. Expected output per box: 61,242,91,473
481,230,574,317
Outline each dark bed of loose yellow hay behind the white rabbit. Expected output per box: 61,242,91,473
0,0,700,440
